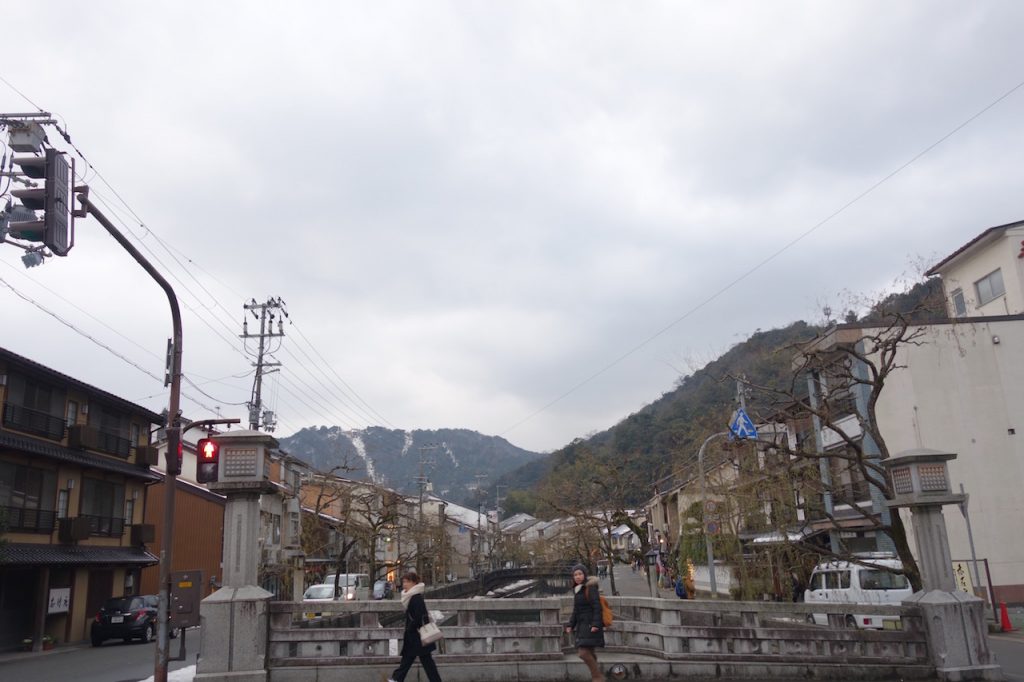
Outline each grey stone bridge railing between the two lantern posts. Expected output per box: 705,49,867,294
267,596,931,667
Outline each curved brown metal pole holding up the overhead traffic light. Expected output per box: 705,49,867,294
75,187,181,682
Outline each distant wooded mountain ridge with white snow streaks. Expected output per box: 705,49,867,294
279,426,546,502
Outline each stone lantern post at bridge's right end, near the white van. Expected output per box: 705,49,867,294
882,449,1002,682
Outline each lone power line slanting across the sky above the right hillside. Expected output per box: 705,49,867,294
500,74,1024,436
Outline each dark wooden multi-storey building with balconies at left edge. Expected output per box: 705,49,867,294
0,348,163,649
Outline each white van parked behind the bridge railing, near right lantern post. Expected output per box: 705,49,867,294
804,554,913,630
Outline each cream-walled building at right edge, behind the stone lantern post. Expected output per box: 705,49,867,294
833,221,1024,603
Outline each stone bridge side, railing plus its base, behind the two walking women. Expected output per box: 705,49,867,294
253,597,974,682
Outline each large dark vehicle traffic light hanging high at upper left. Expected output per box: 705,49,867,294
7,148,75,256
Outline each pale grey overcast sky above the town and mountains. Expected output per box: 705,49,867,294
0,0,1024,451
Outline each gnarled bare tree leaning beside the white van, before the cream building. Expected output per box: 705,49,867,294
733,299,946,590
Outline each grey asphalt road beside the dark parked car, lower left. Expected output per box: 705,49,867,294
0,629,199,682
